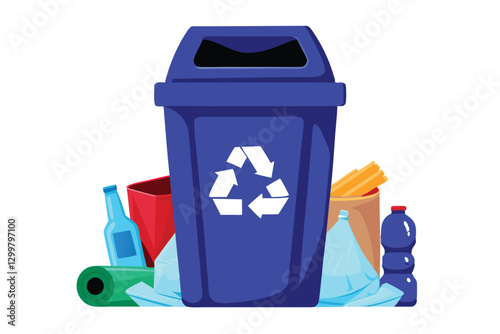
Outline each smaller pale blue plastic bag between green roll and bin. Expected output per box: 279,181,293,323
127,234,184,306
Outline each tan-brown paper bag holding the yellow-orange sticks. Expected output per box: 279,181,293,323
327,188,380,276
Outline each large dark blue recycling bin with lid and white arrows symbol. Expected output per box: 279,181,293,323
155,27,345,307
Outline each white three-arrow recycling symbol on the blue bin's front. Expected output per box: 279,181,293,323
209,146,289,218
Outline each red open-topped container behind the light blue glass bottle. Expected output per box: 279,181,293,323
127,176,175,267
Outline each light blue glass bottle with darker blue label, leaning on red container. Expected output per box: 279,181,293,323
103,185,146,267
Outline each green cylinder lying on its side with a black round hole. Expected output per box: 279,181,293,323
76,266,154,306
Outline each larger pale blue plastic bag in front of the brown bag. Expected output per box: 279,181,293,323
318,213,403,307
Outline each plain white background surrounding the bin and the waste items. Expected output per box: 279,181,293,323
0,0,500,334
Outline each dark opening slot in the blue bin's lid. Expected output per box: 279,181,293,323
194,36,307,67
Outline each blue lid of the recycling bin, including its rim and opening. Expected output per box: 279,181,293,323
155,26,346,107
